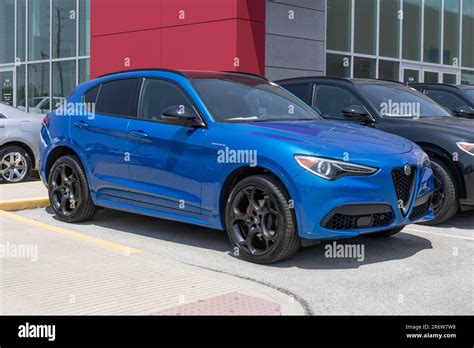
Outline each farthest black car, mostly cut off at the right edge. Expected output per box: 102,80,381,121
410,83,474,119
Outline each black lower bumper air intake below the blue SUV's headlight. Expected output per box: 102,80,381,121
326,212,393,230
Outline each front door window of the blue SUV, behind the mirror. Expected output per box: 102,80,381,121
139,79,195,122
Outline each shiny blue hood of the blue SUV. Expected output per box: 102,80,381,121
223,121,414,155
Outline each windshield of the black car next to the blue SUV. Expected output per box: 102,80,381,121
359,84,451,118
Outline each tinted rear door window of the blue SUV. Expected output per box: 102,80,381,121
96,79,138,116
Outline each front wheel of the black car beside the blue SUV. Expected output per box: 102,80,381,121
421,158,459,226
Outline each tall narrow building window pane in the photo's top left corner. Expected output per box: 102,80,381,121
0,0,15,64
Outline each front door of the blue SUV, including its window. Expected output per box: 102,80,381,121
128,78,207,216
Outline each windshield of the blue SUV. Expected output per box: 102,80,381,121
192,77,321,122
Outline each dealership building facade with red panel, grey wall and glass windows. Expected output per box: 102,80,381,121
0,0,474,112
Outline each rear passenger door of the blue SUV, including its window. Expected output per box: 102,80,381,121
71,78,139,202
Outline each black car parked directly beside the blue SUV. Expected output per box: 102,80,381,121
276,77,474,225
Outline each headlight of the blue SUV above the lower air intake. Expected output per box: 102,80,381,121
295,155,379,180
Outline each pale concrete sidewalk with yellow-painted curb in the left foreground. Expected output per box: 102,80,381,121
0,210,305,315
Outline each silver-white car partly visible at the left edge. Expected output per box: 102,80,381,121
0,103,44,183
